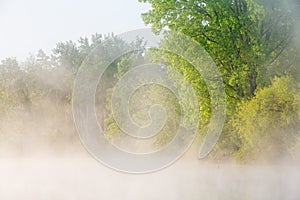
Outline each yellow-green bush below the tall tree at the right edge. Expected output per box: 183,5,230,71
230,77,299,160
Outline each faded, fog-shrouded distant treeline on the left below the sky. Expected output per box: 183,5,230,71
0,34,142,152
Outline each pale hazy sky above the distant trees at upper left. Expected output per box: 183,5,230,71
0,0,150,60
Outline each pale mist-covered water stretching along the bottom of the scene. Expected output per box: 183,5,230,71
0,149,300,200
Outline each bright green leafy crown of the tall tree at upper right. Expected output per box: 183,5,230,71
139,0,294,104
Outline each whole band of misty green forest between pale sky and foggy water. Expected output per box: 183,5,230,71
0,0,300,162
